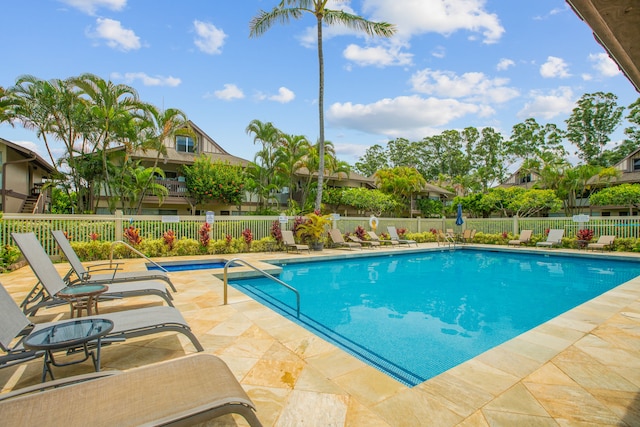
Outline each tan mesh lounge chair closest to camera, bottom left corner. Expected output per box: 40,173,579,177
0,354,262,427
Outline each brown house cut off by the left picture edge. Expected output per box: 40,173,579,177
0,138,55,213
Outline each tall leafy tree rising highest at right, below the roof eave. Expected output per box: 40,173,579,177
565,92,624,166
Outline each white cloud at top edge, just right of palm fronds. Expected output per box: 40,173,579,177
363,0,505,43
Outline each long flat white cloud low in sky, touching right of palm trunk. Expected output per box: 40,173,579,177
327,95,484,139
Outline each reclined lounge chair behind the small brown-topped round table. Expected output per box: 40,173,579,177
11,233,173,315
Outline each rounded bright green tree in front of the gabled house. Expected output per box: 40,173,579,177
182,154,245,211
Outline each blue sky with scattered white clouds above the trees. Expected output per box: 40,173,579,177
0,0,638,169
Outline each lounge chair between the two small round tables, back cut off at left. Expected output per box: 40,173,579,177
0,285,204,372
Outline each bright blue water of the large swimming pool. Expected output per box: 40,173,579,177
231,249,640,386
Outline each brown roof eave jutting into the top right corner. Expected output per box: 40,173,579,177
566,0,640,92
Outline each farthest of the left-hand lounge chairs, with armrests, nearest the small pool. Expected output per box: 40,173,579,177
51,230,176,292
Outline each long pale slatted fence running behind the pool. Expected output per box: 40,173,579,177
0,214,640,254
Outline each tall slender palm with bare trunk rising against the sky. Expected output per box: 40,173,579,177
249,0,396,210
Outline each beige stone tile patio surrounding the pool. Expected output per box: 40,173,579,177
0,244,640,427
